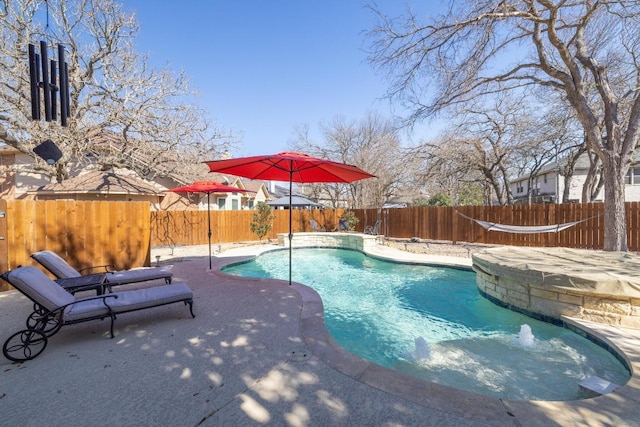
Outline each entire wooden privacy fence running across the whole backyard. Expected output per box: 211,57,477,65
0,200,640,289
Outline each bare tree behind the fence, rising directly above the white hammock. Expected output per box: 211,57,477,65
417,93,570,205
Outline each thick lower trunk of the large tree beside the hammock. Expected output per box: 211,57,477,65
602,156,628,252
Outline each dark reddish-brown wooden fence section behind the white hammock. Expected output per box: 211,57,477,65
355,202,640,251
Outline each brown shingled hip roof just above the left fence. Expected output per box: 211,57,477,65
36,169,164,197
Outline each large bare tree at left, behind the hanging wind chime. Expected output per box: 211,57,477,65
0,0,233,181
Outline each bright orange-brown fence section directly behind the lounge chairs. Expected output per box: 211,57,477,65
0,200,151,290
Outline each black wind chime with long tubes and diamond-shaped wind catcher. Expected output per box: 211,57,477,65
29,41,71,165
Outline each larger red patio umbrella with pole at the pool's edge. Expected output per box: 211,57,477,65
205,152,375,284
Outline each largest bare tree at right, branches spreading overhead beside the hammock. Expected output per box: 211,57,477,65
370,0,640,251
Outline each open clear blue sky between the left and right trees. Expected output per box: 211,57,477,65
121,0,438,156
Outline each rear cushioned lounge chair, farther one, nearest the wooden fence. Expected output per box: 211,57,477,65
31,251,173,294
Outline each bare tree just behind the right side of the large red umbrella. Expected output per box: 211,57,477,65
295,113,406,208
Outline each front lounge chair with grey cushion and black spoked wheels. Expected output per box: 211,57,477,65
0,266,195,362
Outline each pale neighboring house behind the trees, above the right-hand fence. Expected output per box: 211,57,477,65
509,150,640,203
